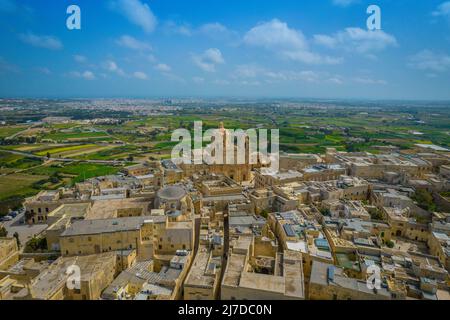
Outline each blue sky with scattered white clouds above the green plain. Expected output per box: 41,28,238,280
0,0,450,100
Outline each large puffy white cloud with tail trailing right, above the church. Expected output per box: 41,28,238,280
244,19,341,64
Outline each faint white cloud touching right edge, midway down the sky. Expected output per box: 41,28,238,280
408,50,450,73
